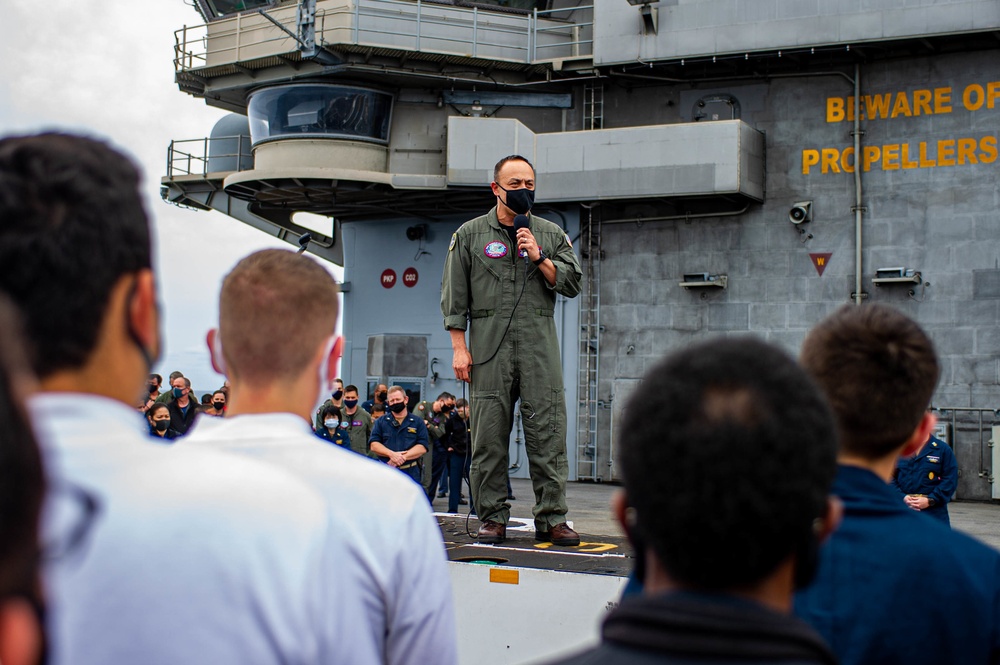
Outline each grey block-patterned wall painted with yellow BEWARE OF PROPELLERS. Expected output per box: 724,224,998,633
598,51,1000,499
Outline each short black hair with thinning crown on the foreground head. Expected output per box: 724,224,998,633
620,338,837,590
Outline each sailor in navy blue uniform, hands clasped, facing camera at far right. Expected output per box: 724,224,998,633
892,436,958,526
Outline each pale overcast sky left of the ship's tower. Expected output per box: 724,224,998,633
0,0,340,395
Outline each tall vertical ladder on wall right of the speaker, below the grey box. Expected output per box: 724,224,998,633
576,207,603,481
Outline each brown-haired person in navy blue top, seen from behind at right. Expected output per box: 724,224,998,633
795,304,1000,665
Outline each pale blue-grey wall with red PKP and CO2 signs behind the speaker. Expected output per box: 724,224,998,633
341,210,580,480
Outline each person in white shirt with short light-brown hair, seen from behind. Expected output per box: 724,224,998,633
181,250,457,665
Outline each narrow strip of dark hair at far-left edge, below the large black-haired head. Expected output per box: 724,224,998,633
0,295,45,604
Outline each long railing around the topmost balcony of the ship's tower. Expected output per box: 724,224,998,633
174,0,594,72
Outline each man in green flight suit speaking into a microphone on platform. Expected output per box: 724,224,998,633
441,155,582,545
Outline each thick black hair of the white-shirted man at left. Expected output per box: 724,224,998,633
0,134,151,378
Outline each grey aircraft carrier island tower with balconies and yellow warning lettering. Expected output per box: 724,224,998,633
162,0,1000,500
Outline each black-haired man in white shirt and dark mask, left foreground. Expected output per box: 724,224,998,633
0,134,336,665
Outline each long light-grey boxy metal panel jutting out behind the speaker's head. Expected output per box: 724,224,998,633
447,117,764,202
